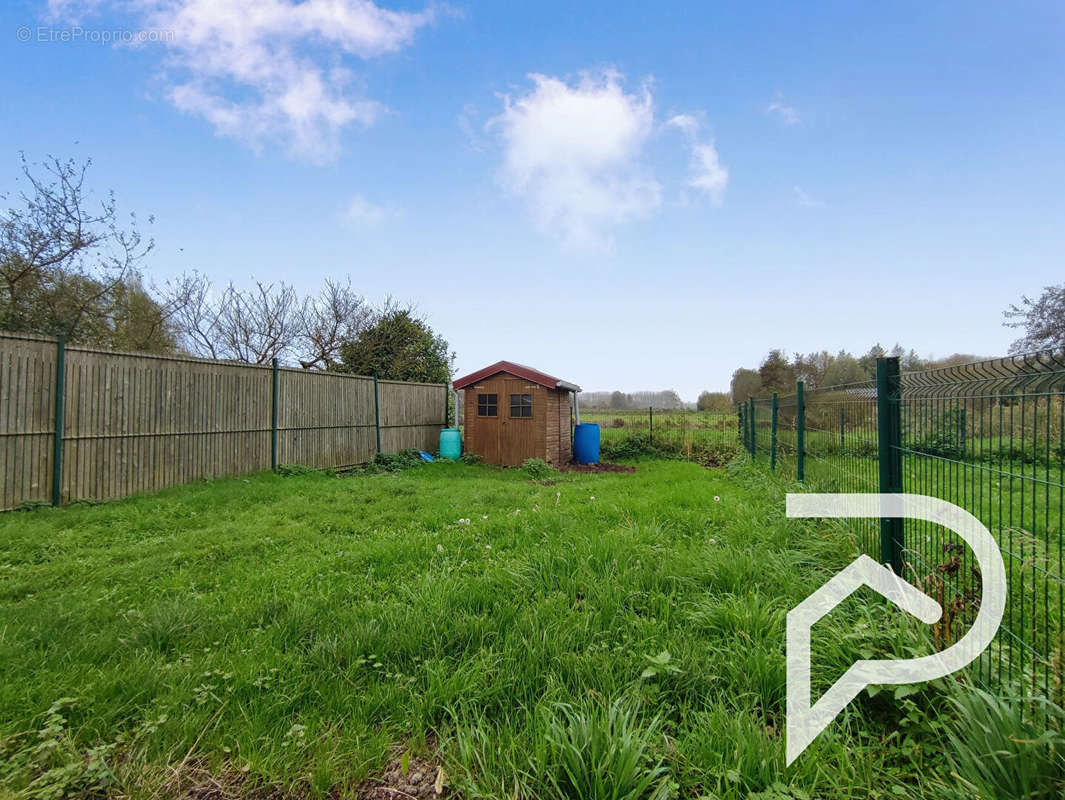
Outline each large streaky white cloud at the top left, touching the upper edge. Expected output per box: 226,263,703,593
51,0,433,163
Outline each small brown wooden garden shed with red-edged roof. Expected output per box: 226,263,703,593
454,361,580,467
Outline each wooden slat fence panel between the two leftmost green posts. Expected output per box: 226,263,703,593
62,347,272,502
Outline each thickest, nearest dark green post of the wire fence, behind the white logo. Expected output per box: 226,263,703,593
876,358,903,575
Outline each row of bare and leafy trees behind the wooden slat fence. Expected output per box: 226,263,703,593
0,156,455,382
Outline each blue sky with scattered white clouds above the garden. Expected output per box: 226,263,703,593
0,0,1065,399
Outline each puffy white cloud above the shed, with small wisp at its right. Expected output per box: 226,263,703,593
487,69,727,250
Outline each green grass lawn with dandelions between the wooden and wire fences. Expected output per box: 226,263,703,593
0,461,1056,799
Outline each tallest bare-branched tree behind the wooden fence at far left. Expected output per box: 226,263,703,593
0,156,152,342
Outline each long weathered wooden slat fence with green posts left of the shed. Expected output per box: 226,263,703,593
0,333,447,509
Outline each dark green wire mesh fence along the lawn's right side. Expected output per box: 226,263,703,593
738,353,1065,705
